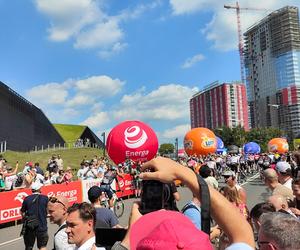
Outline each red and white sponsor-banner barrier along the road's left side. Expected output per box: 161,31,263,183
0,174,134,224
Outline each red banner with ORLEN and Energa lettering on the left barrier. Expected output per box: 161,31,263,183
0,181,82,224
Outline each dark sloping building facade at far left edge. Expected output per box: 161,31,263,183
0,82,64,151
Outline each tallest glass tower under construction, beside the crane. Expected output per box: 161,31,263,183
244,6,300,137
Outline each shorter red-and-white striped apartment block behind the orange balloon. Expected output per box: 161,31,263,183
190,82,249,130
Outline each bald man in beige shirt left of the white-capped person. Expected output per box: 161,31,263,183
264,168,294,200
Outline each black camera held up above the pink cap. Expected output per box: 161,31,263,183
140,180,178,214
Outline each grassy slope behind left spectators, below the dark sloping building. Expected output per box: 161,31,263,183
2,148,103,170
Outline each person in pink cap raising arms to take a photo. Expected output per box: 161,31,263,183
112,157,255,250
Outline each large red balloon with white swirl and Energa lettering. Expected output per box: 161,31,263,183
106,121,158,164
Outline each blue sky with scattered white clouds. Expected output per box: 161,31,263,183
0,0,300,144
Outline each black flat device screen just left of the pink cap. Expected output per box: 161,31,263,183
96,228,127,247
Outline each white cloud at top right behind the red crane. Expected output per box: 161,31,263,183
169,0,299,51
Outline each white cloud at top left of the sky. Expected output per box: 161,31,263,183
34,0,161,58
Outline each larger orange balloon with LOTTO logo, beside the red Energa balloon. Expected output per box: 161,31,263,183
184,128,217,156
